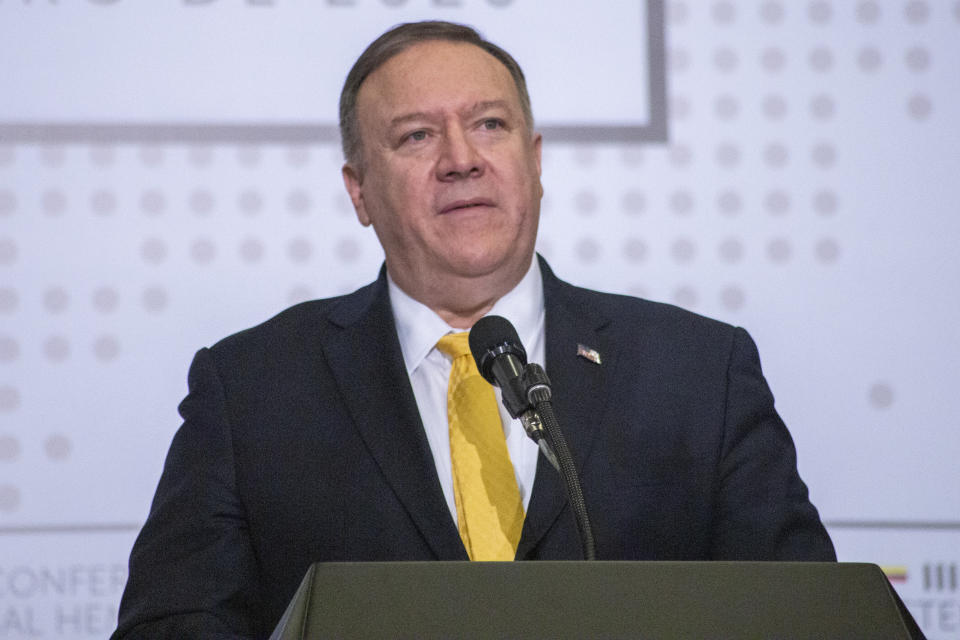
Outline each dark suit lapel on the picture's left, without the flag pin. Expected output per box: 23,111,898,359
323,270,467,560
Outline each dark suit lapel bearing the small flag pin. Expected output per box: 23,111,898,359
517,258,615,559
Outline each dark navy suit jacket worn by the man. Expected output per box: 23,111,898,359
110,262,835,638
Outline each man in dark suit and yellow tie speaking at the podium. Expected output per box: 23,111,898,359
110,23,835,638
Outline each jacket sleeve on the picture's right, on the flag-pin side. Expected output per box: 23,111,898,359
712,328,836,561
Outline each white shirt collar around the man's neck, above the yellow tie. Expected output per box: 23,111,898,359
387,257,544,375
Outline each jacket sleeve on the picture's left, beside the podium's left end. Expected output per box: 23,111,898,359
113,349,262,639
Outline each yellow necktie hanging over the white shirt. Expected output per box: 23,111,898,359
437,332,524,560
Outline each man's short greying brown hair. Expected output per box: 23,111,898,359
340,21,533,166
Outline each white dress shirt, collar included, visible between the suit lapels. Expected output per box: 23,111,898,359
387,258,546,522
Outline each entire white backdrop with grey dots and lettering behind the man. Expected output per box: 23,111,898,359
0,0,960,638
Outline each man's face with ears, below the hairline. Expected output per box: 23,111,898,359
343,41,543,295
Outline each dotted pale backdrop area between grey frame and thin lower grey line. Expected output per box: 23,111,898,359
0,1,960,540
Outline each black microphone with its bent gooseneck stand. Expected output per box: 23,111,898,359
469,316,596,560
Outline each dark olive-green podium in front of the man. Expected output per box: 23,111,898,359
271,562,923,640
